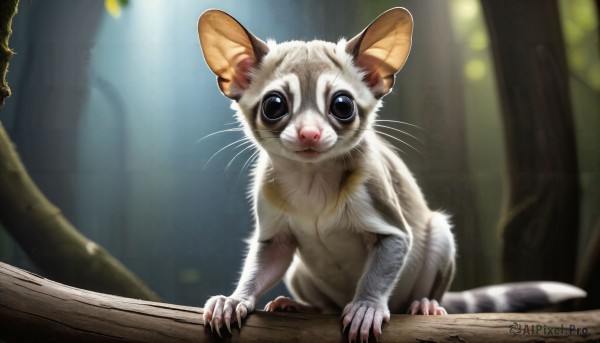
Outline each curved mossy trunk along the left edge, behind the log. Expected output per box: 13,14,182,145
0,1,158,300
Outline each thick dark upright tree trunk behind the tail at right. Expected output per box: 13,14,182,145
481,0,580,284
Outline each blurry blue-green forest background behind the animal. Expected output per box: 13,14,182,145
0,0,600,306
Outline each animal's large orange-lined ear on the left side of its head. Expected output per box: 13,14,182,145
198,10,269,100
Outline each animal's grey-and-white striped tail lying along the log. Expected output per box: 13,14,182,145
441,281,587,313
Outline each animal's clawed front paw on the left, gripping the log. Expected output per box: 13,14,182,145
203,295,255,336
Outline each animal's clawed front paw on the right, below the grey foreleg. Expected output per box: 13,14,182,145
342,300,390,342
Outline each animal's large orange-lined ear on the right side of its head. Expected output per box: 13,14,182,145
346,7,413,98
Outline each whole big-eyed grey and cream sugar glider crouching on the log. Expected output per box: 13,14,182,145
198,8,585,341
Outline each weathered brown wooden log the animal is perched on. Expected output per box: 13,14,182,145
0,263,600,343
